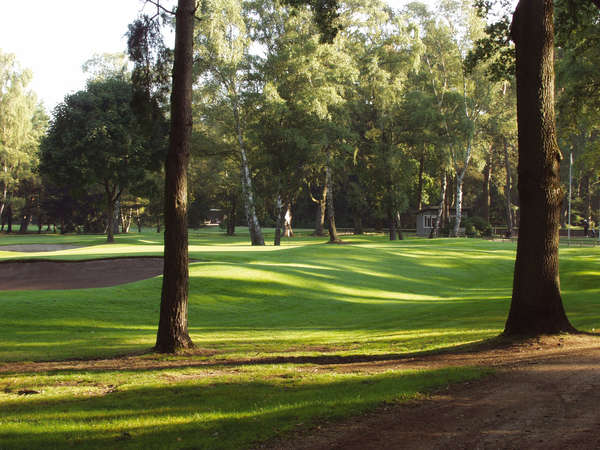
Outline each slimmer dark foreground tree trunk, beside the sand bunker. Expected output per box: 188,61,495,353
155,0,196,353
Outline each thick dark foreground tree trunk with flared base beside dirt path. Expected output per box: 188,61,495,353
504,0,574,335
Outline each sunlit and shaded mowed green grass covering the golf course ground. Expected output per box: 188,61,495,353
0,231,600,448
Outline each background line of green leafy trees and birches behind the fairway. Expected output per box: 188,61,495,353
0,0,600,244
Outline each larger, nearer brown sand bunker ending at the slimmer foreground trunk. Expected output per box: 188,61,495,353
0,258,163,291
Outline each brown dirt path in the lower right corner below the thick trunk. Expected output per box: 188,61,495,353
267,337,600,450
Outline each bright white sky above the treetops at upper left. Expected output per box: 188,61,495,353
0,0,440,112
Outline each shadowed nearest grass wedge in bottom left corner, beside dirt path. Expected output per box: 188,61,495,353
0,369,485,449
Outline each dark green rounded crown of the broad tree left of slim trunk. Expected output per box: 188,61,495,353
40,77,165,236
